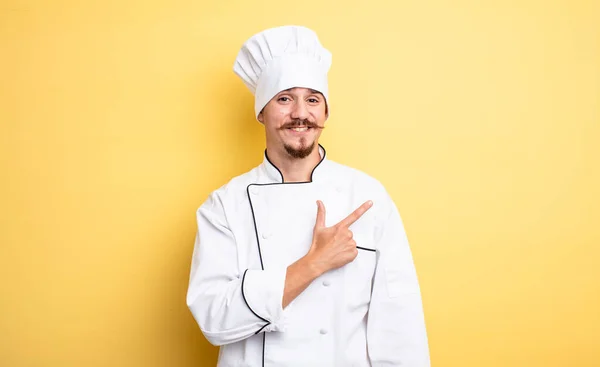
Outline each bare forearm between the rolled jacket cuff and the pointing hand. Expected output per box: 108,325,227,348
282,255,324,308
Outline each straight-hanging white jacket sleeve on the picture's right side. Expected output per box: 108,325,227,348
367,195,430,367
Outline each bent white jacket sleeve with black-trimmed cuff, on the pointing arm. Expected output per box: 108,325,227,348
186,193,287,345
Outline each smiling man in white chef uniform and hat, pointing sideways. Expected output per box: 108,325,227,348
187,26,430,367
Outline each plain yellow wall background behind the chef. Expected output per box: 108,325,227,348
0,0,600,367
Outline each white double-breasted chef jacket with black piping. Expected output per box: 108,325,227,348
187,146,430,367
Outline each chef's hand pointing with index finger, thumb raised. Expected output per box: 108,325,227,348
307,200,373,273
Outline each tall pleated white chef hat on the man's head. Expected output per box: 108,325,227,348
233,26,331,118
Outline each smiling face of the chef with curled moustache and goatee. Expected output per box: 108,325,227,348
258,88,327,159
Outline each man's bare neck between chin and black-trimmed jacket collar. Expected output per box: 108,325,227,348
267,144,321,182
